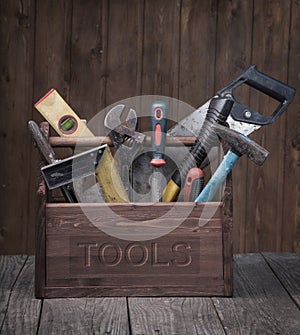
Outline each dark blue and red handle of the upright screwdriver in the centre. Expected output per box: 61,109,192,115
151,101,168,166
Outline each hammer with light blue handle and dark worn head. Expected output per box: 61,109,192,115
195,123,269,202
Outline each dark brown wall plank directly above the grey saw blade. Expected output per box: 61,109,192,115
179,0,217,108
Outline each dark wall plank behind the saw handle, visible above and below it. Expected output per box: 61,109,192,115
246,0,290,252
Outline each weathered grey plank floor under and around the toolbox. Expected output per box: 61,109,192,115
0,253,300,335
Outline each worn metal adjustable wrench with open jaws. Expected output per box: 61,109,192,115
104,104,146,199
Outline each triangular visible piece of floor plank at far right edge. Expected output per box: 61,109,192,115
263,253,300,308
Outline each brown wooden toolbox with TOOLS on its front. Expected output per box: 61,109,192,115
35,123,232,298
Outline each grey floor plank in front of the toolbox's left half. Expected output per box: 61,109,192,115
39,298,129,335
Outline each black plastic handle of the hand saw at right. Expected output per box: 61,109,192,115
217,65,296,126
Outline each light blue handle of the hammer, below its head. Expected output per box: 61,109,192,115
195,150,240,202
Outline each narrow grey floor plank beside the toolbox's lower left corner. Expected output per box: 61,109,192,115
1,256,41,334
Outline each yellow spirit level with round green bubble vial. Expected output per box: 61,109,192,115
34,89,129,202
